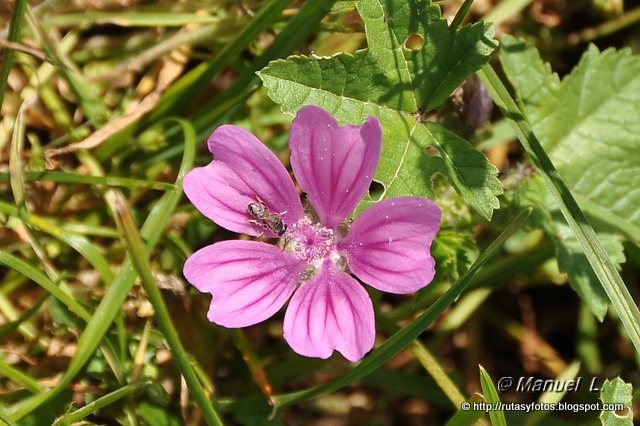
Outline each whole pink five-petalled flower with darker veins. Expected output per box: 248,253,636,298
184,106,440,361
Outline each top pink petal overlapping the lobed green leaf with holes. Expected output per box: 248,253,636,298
289,106,382,228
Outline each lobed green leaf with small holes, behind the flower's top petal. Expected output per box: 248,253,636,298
259,0,502,219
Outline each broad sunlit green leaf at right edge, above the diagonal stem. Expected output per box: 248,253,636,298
500,37,640,242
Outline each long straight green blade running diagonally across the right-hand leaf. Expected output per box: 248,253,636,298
478,65,640,354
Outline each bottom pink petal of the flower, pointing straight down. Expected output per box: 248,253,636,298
284,261,375,362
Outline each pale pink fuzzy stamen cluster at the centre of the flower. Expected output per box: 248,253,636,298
286,217,334,263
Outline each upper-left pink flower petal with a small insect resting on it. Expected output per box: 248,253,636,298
183,125,304,237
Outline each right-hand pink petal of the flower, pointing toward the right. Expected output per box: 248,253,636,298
338,197,440,294
